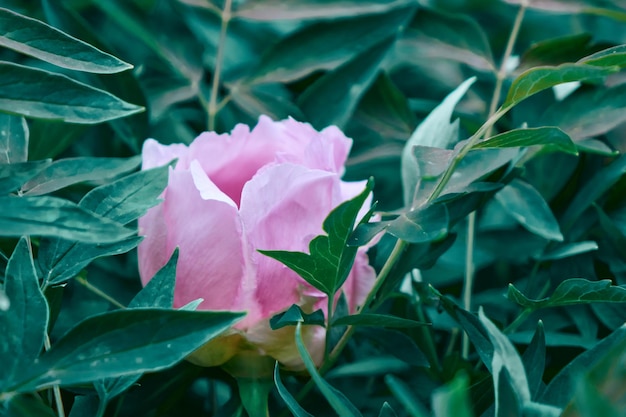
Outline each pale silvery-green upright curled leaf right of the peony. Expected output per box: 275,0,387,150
401,78,476,208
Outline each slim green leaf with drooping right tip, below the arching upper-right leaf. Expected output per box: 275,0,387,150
472,127,578,155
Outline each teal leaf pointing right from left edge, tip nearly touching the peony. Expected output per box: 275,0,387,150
0,197,134,244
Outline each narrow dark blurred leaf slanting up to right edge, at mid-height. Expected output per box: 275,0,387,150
561,156,626,230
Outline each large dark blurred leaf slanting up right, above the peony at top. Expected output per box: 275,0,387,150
251,6,413,84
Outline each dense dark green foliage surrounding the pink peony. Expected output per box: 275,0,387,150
0,0,626,417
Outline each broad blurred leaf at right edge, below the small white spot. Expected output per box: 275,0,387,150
539,84,626,141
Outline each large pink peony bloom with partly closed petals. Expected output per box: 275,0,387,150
139,116,375,370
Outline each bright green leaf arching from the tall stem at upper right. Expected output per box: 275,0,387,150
502,64,619,108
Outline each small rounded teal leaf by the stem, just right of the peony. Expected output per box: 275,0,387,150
387,204,449,243
